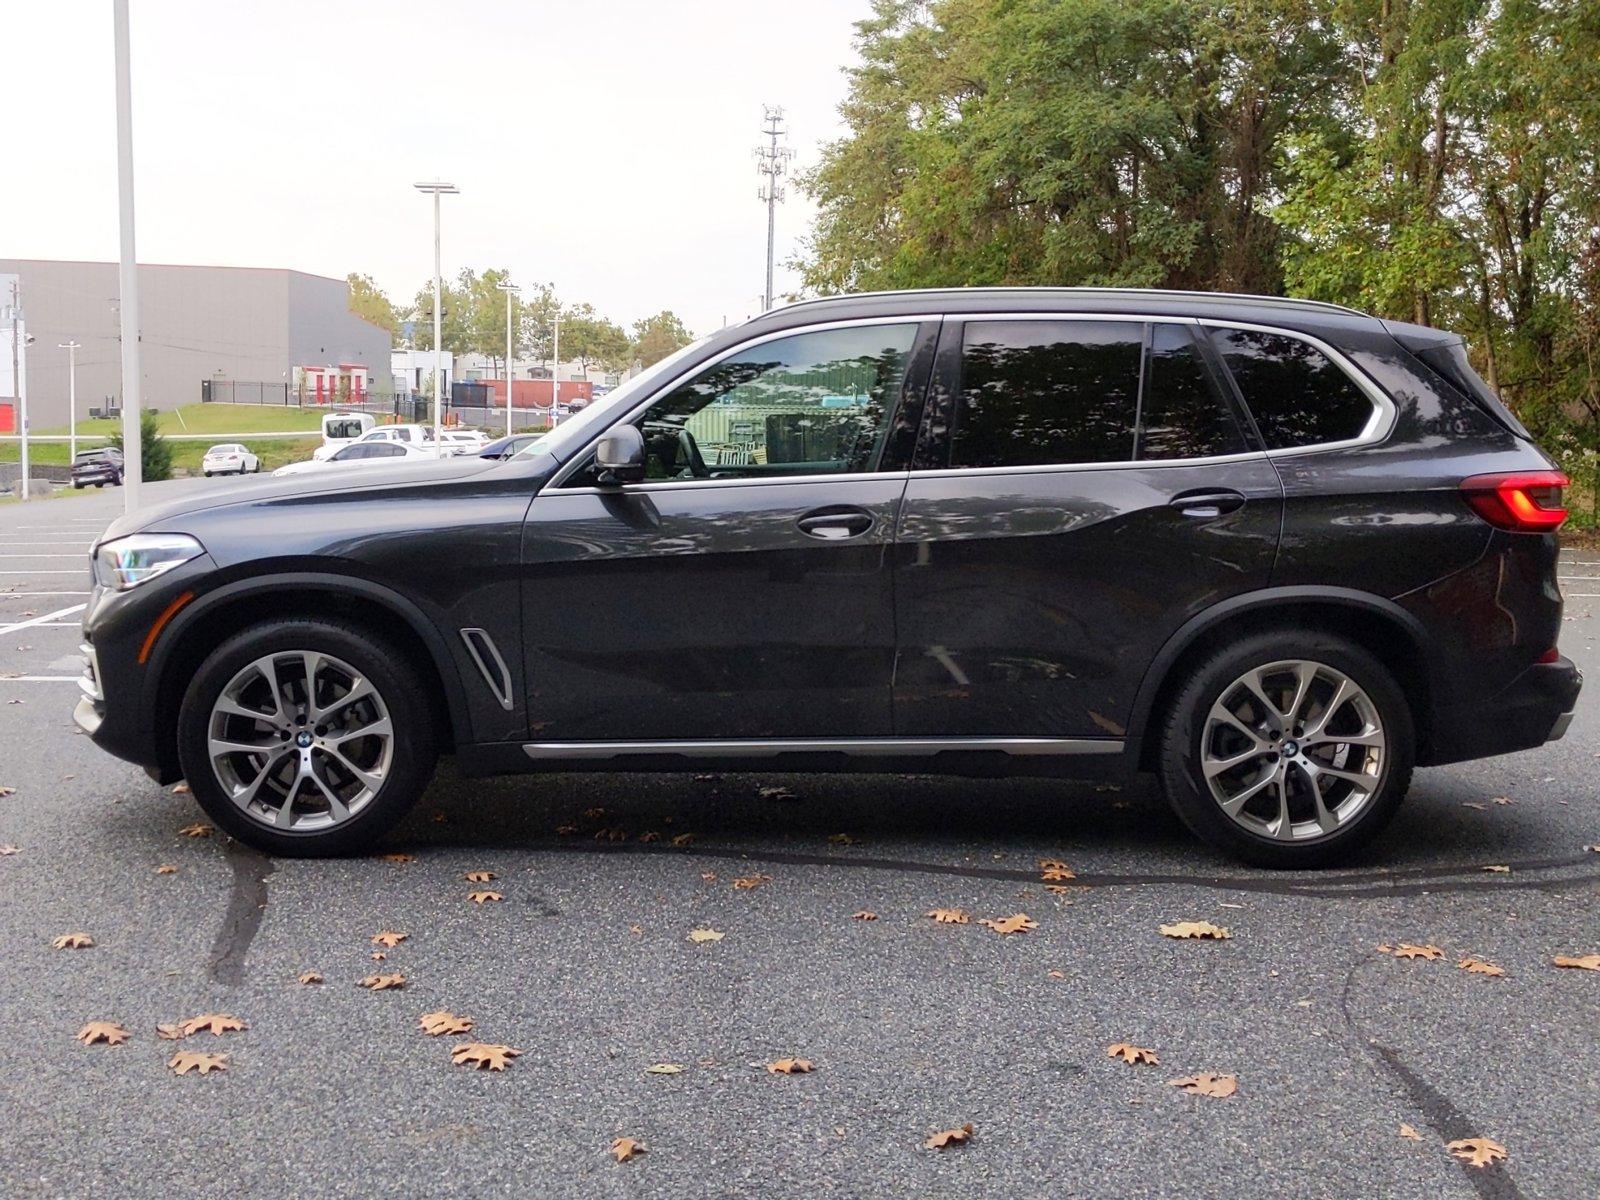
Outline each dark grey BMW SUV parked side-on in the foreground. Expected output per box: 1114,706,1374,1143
77,290,1581,867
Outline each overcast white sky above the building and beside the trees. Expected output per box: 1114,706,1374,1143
0,0,869,333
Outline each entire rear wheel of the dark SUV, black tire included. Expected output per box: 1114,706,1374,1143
1160,629,1416,869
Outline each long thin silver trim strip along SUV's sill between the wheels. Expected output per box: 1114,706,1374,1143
522,738,1123,760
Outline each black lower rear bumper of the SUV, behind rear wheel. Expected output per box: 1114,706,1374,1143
1421,658,1584,766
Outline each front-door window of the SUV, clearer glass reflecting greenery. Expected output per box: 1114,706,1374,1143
568,323,918,486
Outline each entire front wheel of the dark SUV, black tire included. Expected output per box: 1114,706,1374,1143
178,618,437,858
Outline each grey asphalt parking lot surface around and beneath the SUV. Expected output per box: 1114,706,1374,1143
0,480,1600,1200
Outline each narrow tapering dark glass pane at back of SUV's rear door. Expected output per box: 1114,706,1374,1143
1139,325,1250,459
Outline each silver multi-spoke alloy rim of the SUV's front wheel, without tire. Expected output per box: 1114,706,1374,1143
206,650,395,834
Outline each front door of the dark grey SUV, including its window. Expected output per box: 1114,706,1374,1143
523,320,936,742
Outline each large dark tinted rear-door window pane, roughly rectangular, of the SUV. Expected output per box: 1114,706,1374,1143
950,322,1144,467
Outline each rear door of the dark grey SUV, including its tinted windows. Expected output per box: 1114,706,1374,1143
894,314,1283,749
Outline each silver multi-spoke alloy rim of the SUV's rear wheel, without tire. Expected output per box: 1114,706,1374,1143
1200,659,1387,842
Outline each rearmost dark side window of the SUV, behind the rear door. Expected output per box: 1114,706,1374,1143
1211,330,1373,450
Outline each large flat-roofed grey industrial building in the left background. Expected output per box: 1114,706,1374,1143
0,259,390,430
